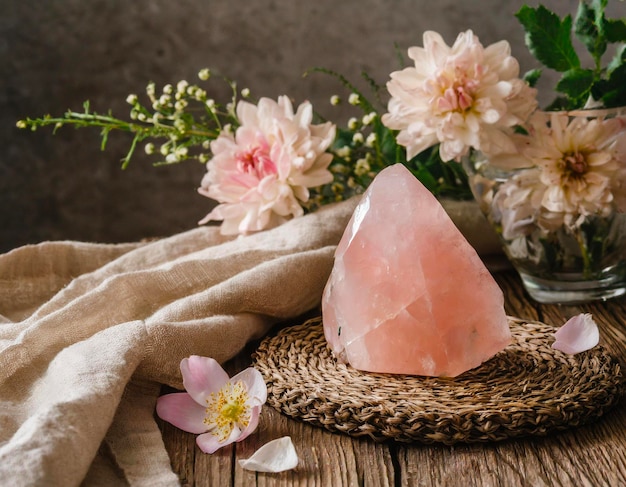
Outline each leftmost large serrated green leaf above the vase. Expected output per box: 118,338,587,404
515,5,580,72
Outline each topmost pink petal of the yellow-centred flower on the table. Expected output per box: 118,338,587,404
180,355,228,406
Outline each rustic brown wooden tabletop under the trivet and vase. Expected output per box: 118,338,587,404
159,271,626,487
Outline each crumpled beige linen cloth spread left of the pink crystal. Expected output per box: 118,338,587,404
0,200,356,487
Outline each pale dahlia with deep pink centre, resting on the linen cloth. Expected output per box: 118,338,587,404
198,96,335,235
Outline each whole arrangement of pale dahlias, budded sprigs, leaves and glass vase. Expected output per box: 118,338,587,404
18,0,626,302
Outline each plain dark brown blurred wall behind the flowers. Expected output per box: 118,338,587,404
0,0,604,252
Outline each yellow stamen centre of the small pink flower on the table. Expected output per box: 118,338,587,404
204,381,250,442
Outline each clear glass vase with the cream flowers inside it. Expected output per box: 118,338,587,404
463,110,626,304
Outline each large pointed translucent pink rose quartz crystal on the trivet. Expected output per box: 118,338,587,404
322,164,511,377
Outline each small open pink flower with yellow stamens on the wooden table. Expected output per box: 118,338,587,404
156,355,267,453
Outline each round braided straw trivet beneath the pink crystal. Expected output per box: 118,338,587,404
254,318,623,445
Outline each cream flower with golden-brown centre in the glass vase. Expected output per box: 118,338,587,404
492,112,626,239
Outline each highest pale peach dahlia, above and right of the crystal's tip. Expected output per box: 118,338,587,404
382,30,537,161
